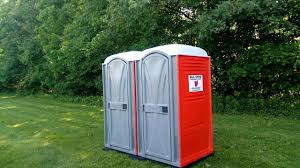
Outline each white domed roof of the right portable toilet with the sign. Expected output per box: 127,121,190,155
143,44,209,57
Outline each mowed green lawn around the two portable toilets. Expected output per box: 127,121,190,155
0,94,300,168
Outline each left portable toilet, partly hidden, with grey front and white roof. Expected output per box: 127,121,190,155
102,51,141,155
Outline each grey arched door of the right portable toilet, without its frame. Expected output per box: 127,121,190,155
141,53,171,160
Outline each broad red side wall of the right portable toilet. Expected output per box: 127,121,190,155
177,56,213,167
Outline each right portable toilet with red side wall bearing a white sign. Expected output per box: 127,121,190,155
136,44,213,167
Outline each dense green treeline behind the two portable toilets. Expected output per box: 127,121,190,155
0,0,300,115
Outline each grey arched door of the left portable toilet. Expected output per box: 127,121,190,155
108,59,130,150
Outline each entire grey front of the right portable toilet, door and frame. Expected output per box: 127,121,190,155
136,51,179,166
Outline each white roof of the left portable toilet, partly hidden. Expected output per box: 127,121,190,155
103,51,142,64
